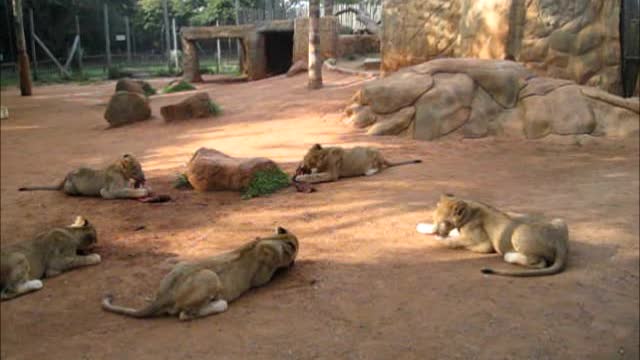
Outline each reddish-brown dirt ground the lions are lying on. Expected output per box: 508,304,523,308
0,73,640,360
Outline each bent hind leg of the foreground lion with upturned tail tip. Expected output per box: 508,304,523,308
174,269,227,321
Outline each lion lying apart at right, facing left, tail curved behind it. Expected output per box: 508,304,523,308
417,194,569,277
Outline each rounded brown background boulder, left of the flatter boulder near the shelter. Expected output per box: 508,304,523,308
104,91,151,126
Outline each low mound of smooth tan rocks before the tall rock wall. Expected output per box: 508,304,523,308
345,58,640,140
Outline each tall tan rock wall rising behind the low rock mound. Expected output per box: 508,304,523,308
381,0,637,95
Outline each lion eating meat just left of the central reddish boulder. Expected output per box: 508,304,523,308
18,154,149,199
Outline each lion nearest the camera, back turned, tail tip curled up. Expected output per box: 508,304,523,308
102,227,298,321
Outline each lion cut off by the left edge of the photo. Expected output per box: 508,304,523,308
0,216,100,301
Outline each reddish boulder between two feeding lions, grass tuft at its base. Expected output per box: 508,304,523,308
187,148,278,191
